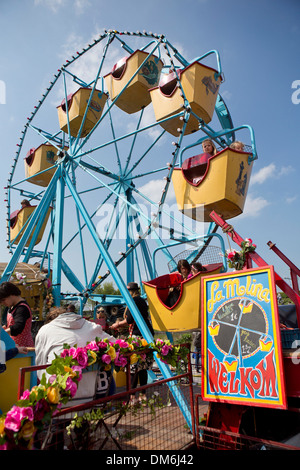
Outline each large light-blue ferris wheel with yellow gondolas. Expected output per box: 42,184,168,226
1,30,255,320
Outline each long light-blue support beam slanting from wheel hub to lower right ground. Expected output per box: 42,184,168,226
64,173,192,428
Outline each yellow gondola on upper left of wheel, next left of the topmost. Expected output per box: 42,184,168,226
57,88,108,137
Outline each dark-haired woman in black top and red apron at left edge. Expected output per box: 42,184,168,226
0,282,34,347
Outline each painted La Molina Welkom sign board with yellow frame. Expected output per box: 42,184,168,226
202,266,287,409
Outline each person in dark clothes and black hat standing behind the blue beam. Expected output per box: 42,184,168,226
111,282,154,405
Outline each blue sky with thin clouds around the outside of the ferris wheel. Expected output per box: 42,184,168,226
0,0,300,292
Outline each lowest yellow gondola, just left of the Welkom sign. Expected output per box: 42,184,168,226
143,263,223,332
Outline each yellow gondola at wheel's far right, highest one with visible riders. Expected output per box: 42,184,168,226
172,148,252,222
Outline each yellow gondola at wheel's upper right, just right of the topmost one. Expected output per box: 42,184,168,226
150,62,221,136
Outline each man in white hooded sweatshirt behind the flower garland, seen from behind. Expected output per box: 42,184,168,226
35,307,116,405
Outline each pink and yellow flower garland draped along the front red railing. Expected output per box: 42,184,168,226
0,337,188,450
